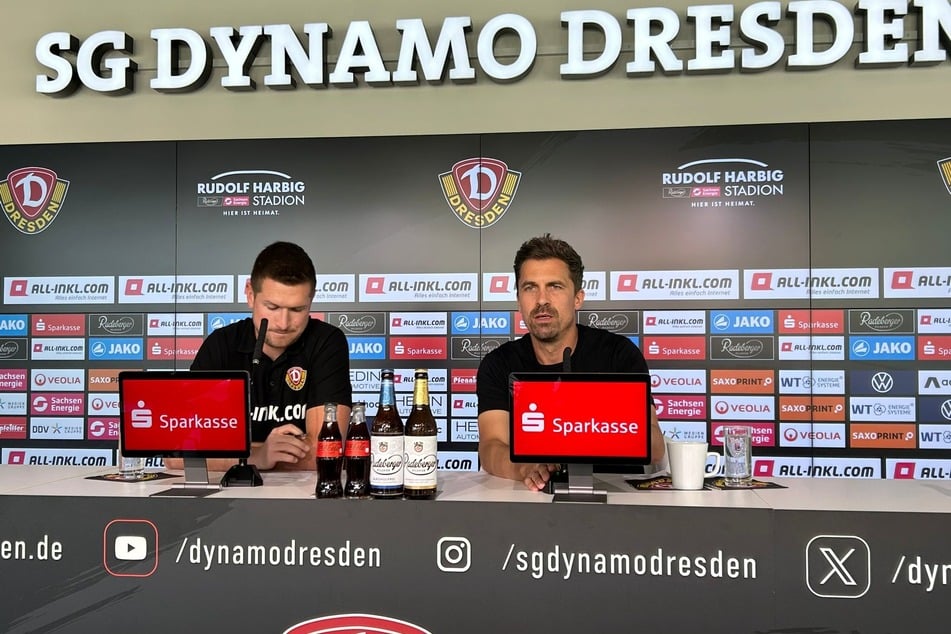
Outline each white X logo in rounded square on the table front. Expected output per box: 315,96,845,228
806,535,872,599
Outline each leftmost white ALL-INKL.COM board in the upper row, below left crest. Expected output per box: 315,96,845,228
3,276,116,305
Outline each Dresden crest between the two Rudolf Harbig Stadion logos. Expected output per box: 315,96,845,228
439,157,522,229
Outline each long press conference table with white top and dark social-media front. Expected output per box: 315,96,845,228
0,465,951,634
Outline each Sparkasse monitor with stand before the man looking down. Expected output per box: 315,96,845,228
119,370,251,487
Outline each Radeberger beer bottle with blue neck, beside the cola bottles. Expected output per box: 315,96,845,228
370,370,403,500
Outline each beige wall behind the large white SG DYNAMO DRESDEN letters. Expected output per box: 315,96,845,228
0,0,951,144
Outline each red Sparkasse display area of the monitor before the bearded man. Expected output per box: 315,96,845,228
511,379,650,462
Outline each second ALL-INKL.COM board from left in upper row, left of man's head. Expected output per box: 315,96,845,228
119,275,235,304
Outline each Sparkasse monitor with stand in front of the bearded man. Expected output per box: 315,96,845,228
509,372,651,502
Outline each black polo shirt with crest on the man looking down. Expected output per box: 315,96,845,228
191,317,352,442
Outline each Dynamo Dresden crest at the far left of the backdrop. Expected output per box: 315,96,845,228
0,167,69,234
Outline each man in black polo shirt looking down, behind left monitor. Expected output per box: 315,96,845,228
184,242,352,471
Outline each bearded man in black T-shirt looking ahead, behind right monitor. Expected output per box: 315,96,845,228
476,234,664,491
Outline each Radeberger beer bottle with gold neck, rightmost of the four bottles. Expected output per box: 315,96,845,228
403,370,437,500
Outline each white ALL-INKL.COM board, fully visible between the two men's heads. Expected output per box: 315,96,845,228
359,273,478,303
